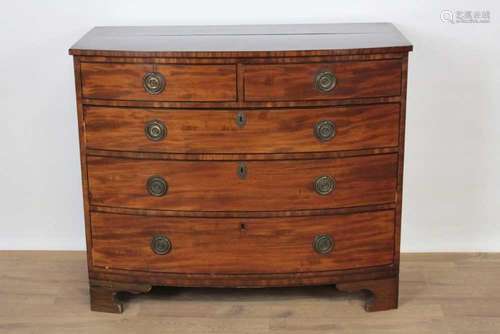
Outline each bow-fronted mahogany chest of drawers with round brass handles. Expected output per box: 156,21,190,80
70,24,412,312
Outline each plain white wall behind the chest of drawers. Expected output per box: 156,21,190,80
0,0,500,251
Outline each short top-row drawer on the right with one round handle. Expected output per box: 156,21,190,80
244,60,401,101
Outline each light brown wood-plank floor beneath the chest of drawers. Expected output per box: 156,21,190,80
0,252,500,334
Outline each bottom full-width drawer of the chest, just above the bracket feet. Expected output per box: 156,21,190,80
91,211,394,274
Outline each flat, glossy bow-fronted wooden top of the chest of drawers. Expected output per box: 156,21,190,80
70,23,412,57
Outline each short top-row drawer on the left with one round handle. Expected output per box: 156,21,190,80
81,63,236,101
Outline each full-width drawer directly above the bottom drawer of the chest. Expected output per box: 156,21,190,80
87,154,397,211
